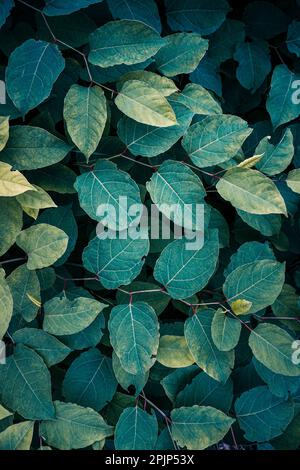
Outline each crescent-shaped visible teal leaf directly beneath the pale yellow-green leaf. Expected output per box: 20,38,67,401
118,95,193,158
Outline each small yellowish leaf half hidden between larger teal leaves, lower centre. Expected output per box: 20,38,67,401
156,335,195,368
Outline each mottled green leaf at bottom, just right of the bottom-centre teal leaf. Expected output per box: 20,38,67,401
171,405,234,450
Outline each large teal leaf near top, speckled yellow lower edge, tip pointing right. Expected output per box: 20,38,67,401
89,20,166,67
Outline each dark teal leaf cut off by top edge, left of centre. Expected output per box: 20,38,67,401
107,0,161,33
